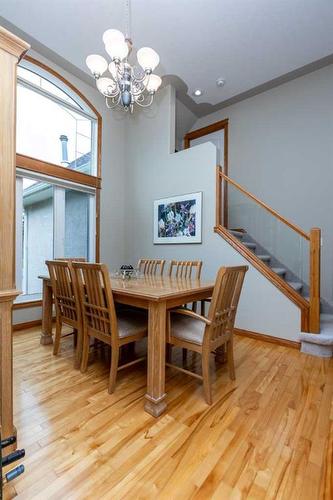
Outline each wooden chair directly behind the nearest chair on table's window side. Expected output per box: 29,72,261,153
46,259,82,368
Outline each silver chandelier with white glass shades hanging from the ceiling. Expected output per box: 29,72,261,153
86,0,162,113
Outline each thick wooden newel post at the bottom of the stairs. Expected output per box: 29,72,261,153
309,227,321,333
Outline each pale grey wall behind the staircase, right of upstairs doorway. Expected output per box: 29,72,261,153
192,65,333,302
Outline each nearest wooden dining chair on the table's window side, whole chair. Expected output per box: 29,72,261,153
72,262,148,394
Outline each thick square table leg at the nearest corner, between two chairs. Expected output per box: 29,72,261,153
145,302,167,417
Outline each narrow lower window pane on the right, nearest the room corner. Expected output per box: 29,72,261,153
64,189,93,260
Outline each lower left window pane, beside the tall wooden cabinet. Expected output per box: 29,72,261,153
19,178,53,299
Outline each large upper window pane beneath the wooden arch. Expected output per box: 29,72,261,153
17,85,96,175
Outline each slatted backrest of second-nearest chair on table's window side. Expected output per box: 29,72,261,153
46,260,81,323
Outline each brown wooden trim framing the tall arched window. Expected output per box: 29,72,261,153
13,55,102,309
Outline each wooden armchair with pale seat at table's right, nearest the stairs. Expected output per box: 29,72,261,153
166,266,248,405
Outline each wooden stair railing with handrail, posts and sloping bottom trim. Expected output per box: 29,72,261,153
215,166,321,333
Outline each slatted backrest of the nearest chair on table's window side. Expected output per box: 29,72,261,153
72,262,118,342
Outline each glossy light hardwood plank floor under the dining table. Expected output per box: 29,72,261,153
5,328,333,500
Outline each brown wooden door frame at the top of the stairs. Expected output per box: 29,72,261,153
184,118,229,227
